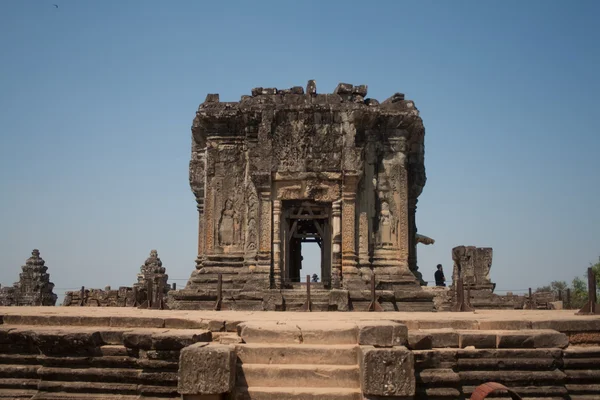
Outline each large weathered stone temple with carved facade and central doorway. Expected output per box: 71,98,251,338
170,81,432,310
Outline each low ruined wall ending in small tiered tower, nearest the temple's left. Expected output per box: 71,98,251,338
63,250,171,307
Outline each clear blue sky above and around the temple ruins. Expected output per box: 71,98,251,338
0,0,600,300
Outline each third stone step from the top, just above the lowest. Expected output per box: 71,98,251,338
237,364,360,388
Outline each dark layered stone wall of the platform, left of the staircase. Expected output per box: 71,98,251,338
0,325,211,400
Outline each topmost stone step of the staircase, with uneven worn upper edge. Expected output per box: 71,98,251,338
238,321,358,344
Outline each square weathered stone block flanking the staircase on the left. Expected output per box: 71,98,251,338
177,343,236,395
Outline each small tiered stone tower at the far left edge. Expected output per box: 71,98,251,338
0,249,57,306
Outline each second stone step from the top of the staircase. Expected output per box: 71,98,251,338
236,343,358,365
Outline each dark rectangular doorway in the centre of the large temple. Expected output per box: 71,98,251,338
281,200,331,288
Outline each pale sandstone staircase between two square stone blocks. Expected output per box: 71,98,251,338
234,331,362,400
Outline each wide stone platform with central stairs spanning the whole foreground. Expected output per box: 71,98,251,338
0,307,600,400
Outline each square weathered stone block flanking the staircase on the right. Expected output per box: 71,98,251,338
359,346,415,396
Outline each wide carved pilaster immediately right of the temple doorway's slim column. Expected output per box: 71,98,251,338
342,175,358,280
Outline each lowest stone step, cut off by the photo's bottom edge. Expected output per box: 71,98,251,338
233,387,363,400
